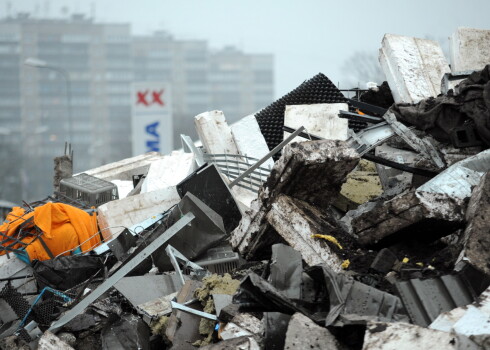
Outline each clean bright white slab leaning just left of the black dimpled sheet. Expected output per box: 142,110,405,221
231,114,274,169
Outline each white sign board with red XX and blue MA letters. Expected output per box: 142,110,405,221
131,82,173,156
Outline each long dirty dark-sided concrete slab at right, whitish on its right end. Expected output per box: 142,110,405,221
342,191,466,245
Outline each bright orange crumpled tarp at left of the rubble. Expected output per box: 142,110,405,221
0,203,100,261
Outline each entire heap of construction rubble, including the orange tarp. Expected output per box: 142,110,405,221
0,28,490,350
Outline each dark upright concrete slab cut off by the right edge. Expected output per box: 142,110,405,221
462,172,490,274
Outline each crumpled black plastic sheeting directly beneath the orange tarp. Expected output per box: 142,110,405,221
32,255,105,291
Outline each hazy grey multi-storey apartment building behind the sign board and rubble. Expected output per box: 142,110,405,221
0,14,273,203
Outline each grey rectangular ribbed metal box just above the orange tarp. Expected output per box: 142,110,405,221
60,173,119,207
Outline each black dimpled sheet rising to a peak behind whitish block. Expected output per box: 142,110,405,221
255,73,347,159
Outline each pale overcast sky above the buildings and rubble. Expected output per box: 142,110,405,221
0,0,490,97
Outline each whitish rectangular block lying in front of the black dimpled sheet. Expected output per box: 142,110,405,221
284,103,349,142
